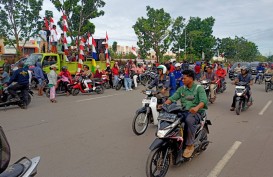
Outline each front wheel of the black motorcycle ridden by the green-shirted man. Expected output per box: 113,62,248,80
146,148,170,177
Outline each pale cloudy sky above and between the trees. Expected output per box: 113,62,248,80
41,0,273,56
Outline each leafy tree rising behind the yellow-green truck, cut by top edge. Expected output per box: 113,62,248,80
50,0,105,43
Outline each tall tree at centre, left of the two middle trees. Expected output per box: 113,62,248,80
133,6,172,61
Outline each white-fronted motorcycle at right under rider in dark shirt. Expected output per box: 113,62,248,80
235,82,253,115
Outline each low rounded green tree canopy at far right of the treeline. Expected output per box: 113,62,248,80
219,36,259,61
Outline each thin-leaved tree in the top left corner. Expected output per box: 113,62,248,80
0,0,43,56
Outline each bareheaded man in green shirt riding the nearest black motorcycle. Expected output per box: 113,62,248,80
165,70,208,158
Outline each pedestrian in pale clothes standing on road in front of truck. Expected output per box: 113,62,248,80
47,64,57,103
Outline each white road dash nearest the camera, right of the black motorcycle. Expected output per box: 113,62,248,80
208,141,242,177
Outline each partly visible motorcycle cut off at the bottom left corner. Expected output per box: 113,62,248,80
0,126,40,177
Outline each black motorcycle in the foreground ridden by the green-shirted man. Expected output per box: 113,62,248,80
146,104,211,177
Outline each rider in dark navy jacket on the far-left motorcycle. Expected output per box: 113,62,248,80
5,62,29,108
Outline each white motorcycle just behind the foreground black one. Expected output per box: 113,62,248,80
132,90,164,135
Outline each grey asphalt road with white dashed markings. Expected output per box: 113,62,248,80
0,79,273,177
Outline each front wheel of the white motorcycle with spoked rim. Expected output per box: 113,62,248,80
132,113,149,135
